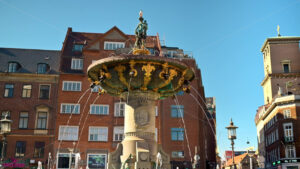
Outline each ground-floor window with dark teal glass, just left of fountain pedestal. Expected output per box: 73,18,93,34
87,154,107,169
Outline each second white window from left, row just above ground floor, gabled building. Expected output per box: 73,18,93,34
89,127,108,141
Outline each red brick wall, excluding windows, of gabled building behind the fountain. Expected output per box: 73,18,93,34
54,27,216,168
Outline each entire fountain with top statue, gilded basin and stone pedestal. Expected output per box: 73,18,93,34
88,12,194,169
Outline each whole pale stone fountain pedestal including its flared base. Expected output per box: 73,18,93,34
108,91,171,169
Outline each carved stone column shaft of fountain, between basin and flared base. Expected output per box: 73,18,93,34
121,92,159,164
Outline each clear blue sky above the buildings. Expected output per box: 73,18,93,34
0,0,300,158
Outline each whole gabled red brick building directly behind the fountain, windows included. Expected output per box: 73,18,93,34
53,27,216,168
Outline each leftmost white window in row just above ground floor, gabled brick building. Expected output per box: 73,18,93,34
58,126,79,141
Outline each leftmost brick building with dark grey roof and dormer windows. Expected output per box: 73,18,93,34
0,48,60,168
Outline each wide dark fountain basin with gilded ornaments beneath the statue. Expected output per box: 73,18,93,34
88,55,194,99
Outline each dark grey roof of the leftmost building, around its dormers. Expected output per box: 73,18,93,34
0,48,60,74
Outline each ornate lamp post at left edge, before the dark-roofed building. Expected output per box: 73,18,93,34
0,115,12,168
